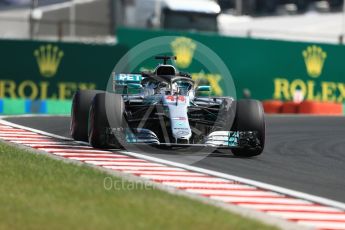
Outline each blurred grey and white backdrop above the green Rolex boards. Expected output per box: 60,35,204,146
0,0,345,43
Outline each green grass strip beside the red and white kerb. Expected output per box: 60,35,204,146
0,142,275,230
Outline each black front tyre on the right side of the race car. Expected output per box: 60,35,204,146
232,99,265,157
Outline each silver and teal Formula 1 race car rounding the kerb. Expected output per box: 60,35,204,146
71,56,265,157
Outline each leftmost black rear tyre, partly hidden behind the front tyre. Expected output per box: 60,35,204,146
70,90,103,141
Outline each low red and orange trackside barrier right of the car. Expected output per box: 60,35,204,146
262,100,345,115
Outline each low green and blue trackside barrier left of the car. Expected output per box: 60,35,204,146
0,98,72,115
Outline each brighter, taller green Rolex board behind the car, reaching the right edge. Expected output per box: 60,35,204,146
118,28,345,102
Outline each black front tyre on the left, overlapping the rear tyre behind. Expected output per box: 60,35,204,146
88,93,124,148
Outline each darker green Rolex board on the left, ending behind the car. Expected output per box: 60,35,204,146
0,40,126,100
